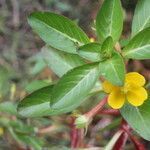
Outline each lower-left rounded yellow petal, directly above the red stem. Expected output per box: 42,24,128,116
108,90,125,109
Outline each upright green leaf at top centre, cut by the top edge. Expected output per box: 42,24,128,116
96,0,123,42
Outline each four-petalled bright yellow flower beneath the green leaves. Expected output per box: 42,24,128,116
103,72,148,109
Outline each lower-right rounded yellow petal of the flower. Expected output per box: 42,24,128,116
127,87,148,106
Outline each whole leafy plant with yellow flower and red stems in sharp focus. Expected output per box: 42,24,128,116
18,0,150,149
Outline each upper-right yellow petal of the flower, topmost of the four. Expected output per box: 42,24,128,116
125,72,145,86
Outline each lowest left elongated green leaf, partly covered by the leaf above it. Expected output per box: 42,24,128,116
18,84,102,117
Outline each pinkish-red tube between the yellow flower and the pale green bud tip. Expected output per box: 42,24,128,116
85,97,107,118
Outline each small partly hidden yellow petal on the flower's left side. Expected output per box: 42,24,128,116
102,80,119,93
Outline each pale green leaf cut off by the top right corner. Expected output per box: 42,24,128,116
132,0,150,36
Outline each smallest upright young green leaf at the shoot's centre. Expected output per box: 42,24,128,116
101,36,114,58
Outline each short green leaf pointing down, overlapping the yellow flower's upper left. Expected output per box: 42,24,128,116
99,52,125,86
